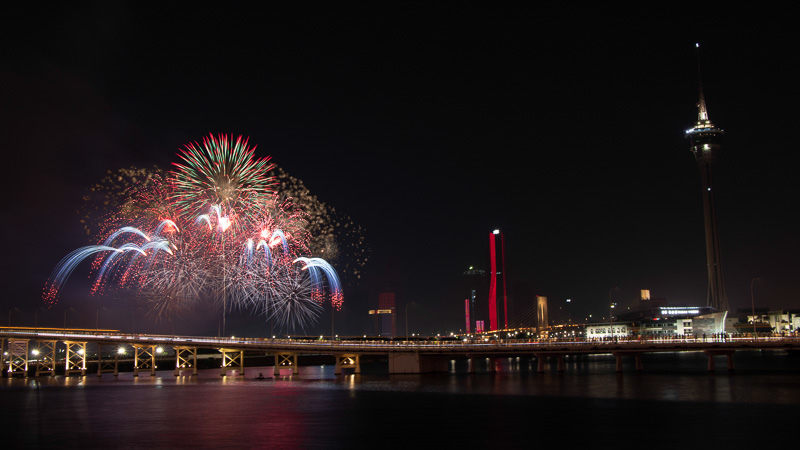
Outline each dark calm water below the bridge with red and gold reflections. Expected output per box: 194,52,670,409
0,352,800,448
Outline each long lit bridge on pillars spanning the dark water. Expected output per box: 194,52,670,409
0,327,800,376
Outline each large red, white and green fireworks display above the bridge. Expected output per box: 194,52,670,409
44,136,342,329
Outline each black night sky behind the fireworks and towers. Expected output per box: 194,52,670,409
0,2,800,334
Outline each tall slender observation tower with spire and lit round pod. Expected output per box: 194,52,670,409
686,44,728,311
